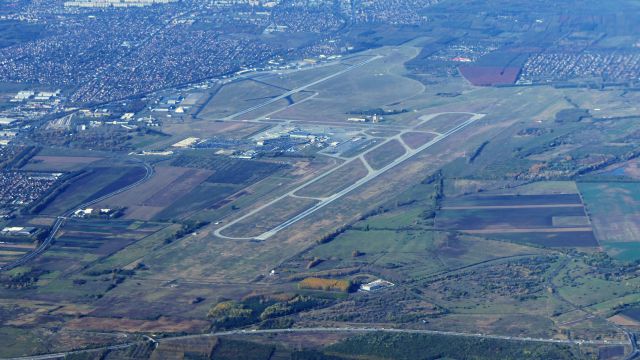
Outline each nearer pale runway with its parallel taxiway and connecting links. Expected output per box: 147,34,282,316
214,112,485,240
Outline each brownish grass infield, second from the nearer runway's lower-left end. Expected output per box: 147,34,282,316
296,159,368,197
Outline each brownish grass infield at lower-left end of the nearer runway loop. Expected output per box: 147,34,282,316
222,197,317,238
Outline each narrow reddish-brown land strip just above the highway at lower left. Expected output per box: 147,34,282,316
66,316,209,332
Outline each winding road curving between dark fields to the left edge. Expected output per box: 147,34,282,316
0,163,153,271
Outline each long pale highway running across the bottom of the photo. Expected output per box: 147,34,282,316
3,327,628,360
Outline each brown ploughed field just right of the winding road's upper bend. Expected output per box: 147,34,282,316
97,166,213,220
